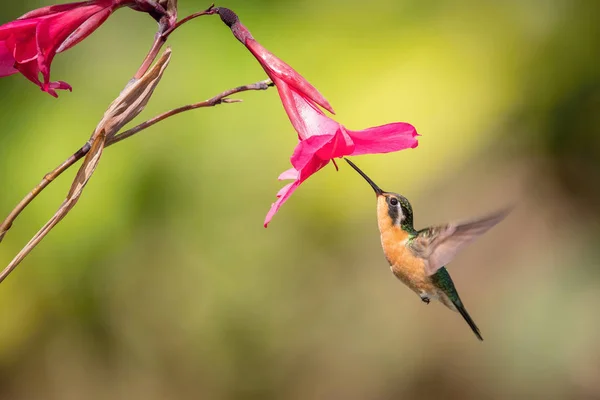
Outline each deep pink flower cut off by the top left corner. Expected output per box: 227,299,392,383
0,0,165,97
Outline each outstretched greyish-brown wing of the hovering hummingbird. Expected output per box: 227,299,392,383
409,209,511,276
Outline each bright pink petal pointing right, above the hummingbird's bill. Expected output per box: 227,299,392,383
347,122,419,156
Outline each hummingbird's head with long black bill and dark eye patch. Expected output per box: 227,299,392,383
344,158,414,231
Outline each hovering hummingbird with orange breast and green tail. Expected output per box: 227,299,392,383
344,158,510,340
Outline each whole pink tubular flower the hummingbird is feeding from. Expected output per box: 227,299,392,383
218,8,418,227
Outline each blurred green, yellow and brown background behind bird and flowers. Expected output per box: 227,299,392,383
0,0,600,400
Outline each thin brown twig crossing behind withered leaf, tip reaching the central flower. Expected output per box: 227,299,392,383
0,79,273,242
